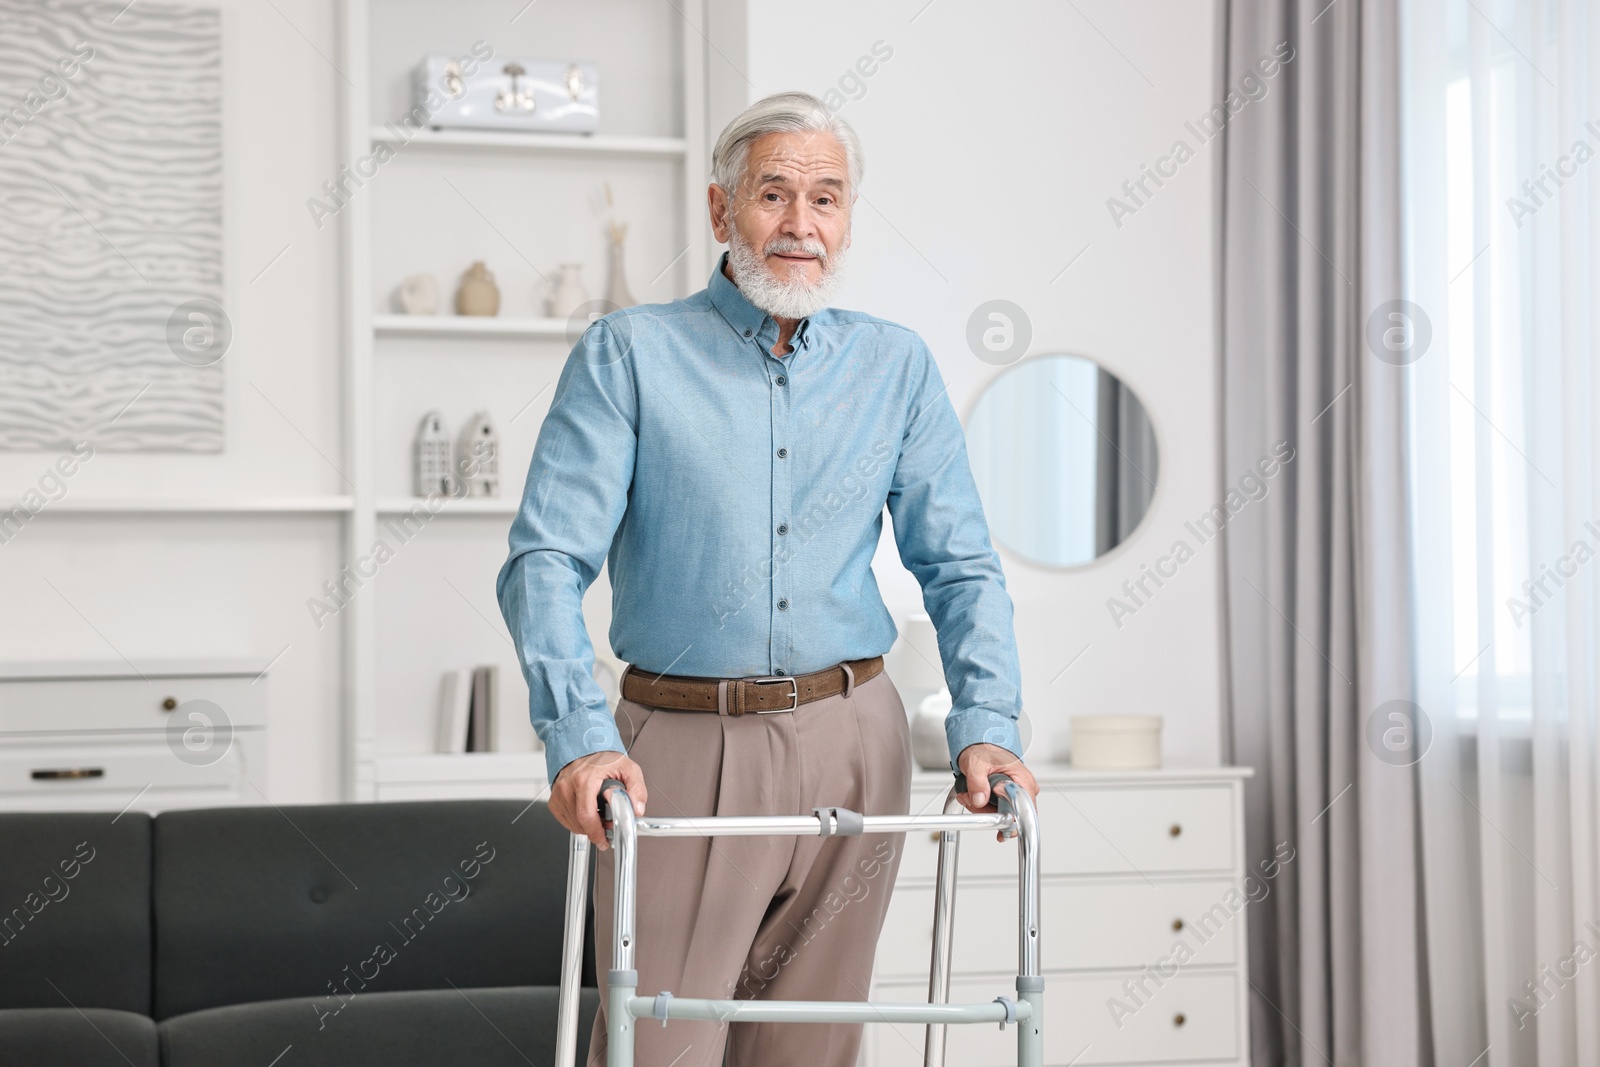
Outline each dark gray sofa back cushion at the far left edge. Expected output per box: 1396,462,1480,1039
0,811,150,1017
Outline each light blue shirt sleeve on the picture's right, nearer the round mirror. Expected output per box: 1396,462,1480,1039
888,341,1022,769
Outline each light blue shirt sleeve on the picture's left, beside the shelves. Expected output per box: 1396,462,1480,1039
494,318,638,782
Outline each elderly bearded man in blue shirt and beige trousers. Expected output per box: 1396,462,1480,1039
496,93,1038,1067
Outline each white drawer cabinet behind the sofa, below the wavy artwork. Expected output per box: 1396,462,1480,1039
0,659,267,811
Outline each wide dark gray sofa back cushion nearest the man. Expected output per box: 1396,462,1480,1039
152,800,595,1017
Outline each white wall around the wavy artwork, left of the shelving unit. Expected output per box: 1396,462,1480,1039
0,0,349,803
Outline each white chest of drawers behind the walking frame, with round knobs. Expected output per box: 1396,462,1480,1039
861,765,1248,1067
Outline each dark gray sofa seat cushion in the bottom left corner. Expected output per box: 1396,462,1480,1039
0,1004,160,1067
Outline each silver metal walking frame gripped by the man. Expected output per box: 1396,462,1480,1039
555,771,1045,1067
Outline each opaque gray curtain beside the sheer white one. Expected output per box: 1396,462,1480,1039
1219,0,1433,1067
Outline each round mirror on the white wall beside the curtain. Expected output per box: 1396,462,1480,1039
966,355,1158,566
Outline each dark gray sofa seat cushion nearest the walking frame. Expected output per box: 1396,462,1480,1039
160,987,600,1067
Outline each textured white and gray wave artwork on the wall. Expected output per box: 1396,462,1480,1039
0,0,230,453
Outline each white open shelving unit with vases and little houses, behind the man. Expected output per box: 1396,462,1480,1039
339,0,709,801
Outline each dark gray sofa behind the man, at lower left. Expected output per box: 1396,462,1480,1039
0,800,598,1067
